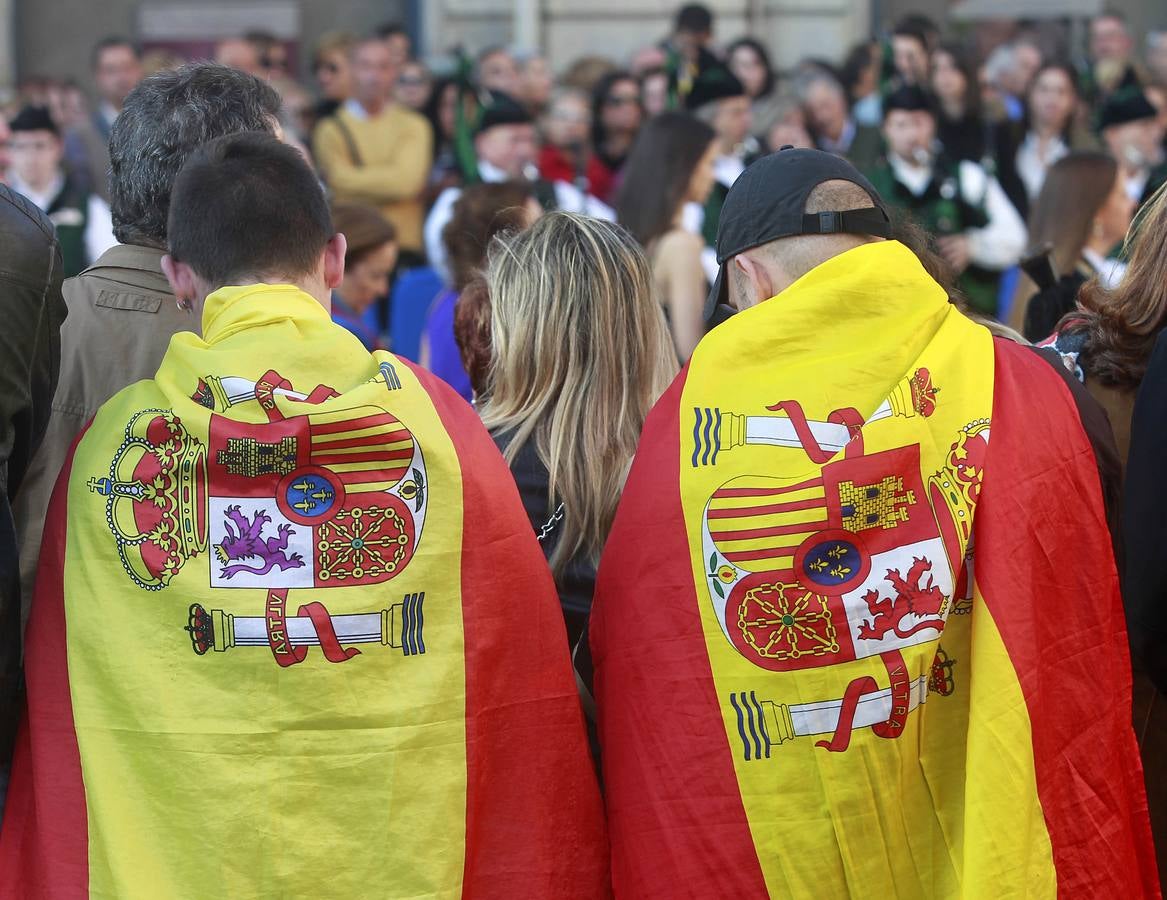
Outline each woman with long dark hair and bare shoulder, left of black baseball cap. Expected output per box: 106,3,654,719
616,112,718,361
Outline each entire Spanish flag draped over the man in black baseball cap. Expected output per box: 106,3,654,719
591,242,1159,899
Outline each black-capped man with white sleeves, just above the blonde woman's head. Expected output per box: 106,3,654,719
425,92,616,280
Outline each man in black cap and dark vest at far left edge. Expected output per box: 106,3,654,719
8,106,90,278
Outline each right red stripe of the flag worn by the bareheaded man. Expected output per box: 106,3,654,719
403,361,608,900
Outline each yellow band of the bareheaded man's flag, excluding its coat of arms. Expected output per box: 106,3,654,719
64,285,466,900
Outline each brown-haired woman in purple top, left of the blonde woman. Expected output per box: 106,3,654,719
420,181,543,402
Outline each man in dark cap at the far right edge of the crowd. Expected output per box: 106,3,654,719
1098,86,1167,203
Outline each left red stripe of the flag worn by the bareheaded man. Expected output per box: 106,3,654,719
0,423,92,896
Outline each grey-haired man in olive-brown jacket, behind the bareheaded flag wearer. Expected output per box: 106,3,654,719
14,63,280,628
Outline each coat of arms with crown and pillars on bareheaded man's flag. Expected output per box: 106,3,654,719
89,371,429,665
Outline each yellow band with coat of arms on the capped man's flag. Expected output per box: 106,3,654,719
680,242,1055,898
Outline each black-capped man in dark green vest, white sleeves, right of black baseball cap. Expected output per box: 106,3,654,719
868,88,1026,315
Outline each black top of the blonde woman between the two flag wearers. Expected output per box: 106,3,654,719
491,432,595,650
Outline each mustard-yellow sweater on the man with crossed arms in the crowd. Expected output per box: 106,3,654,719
312,104,433,252
